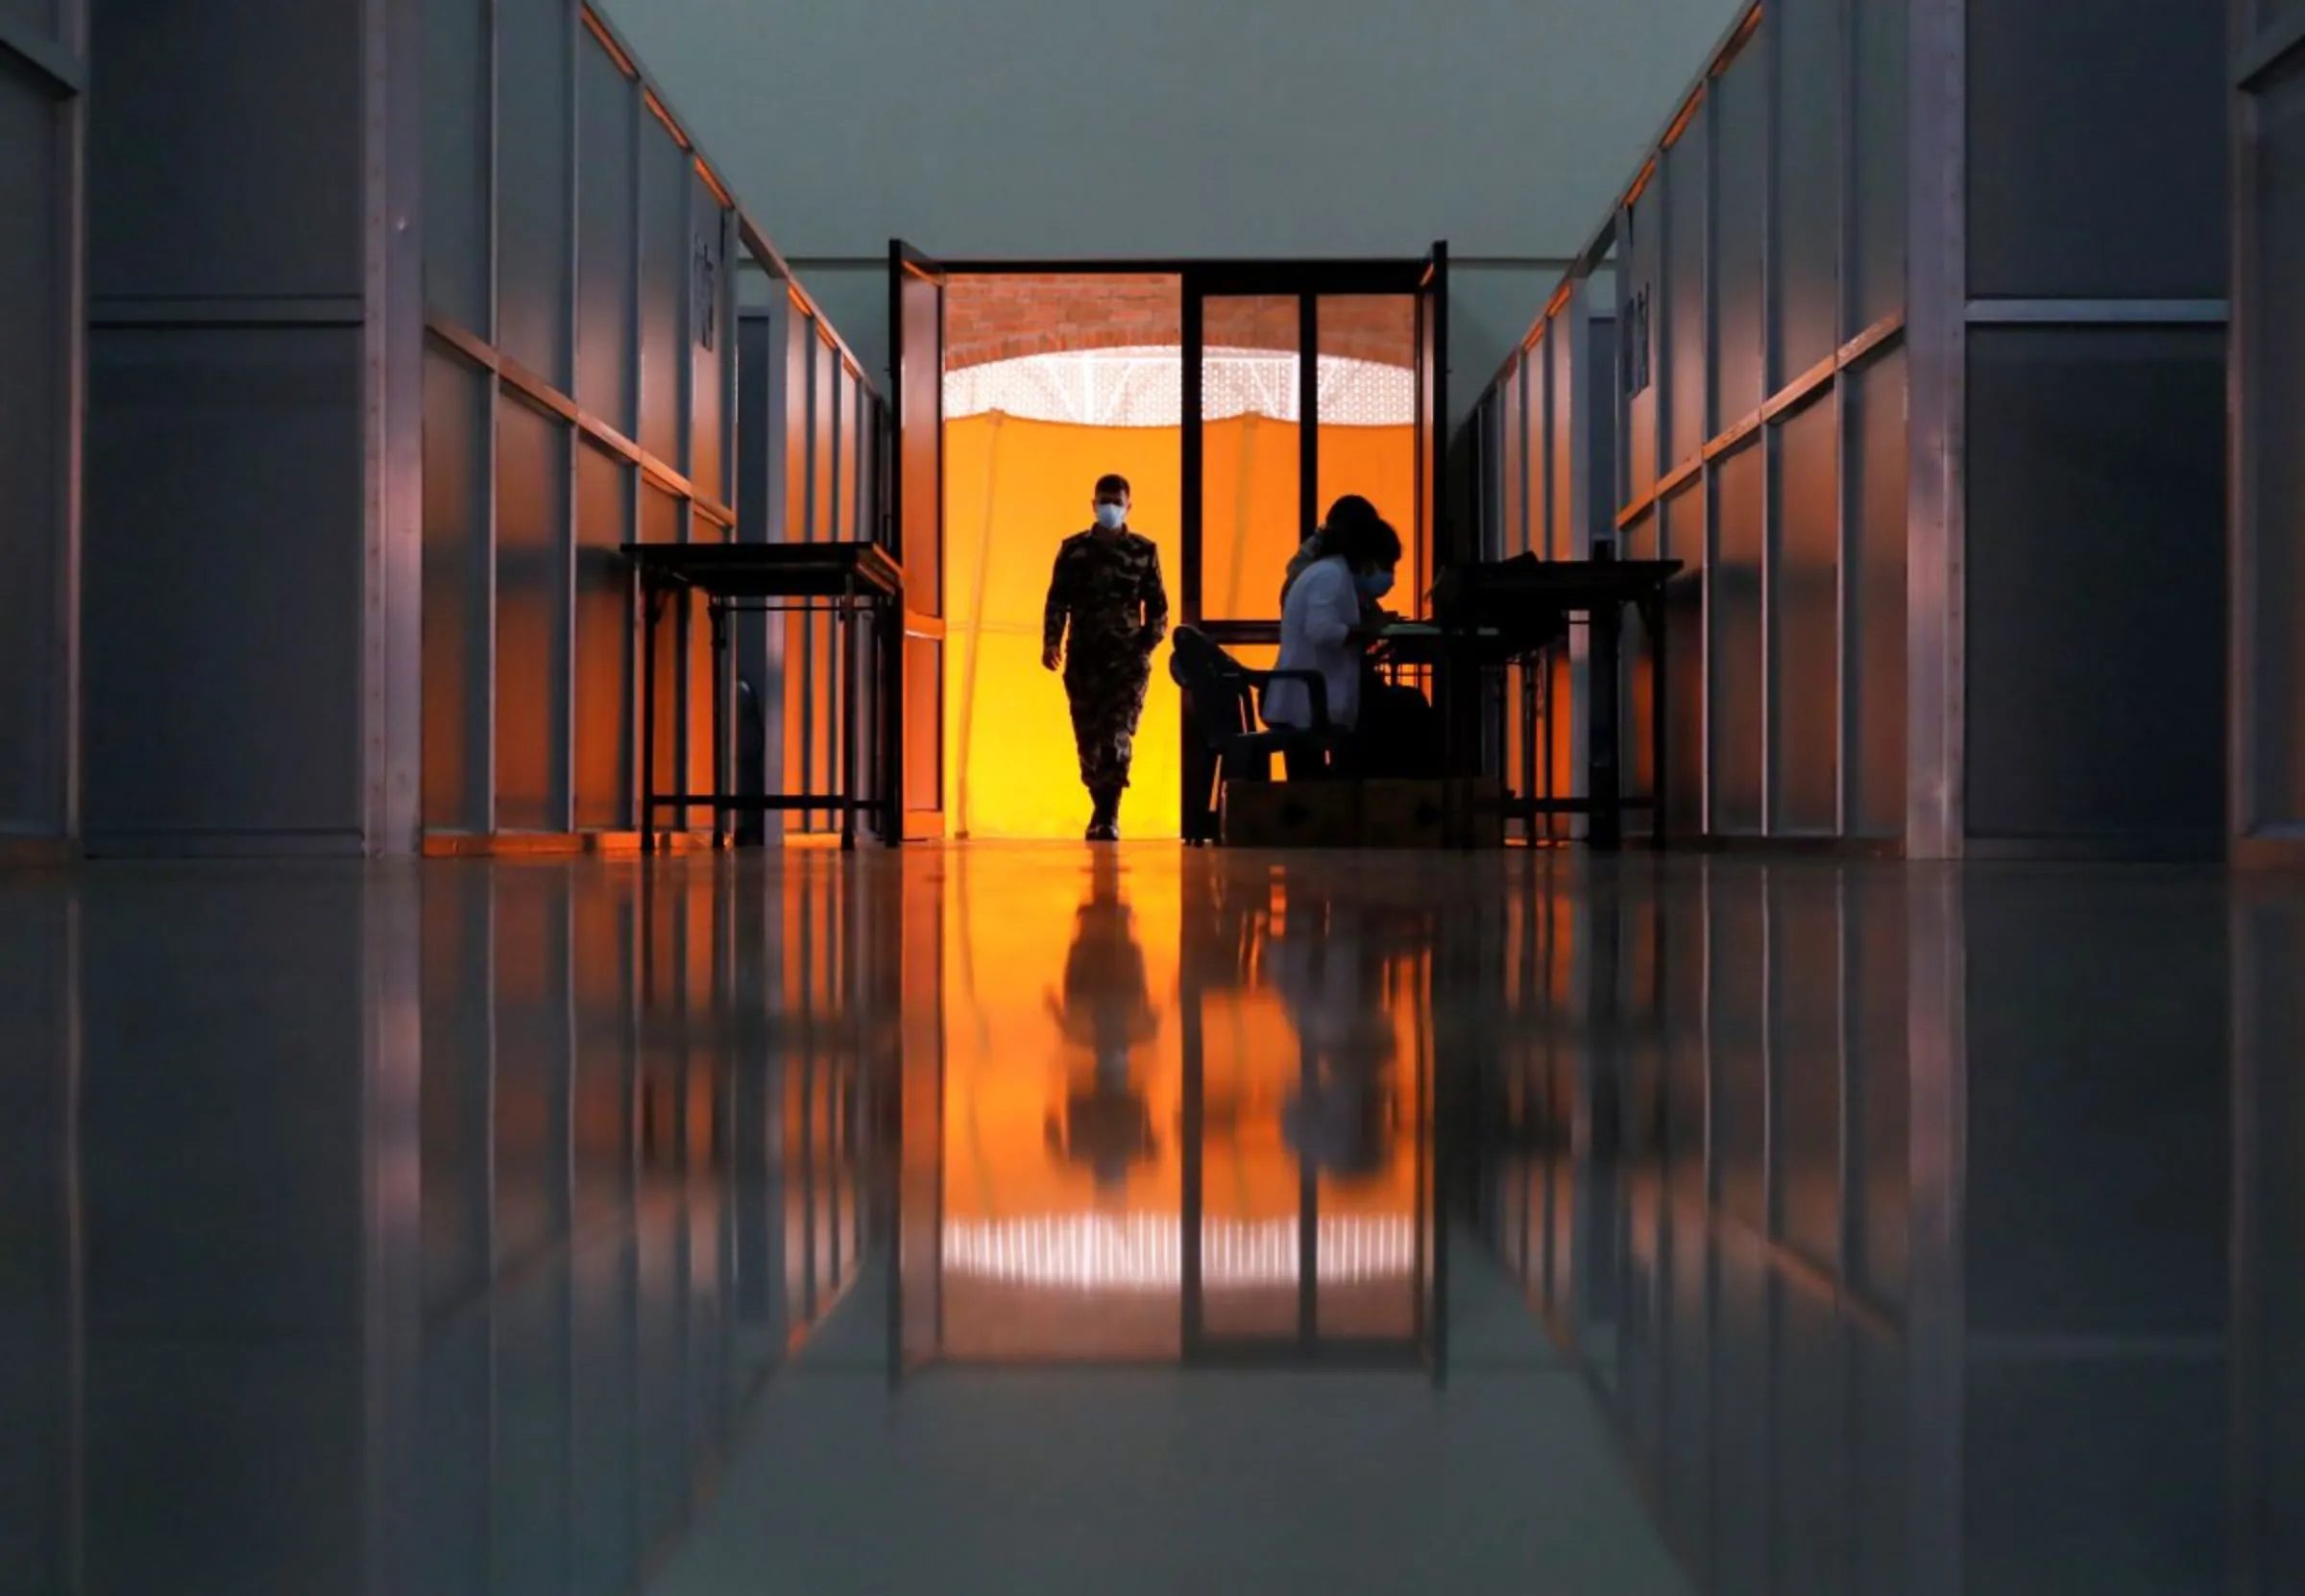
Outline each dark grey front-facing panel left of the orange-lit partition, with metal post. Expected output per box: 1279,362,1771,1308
80,0,422,854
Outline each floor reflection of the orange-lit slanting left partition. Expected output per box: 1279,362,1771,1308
410,869,871,1591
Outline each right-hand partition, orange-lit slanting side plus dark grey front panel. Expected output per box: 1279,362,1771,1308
1482,0,2221,856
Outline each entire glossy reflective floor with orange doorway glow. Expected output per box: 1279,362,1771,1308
0,846,2305,1596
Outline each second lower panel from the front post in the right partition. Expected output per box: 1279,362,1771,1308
1768,397,1842,837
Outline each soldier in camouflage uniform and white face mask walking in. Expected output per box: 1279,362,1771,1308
1039,475,1169,842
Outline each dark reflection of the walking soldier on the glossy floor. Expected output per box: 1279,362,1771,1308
1047,854,1159,1188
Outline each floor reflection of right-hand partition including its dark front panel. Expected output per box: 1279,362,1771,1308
1485,865,2240,1591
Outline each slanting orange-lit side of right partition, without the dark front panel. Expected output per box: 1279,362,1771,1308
1480,0,1934,862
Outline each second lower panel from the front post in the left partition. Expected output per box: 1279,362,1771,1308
496,395,570,831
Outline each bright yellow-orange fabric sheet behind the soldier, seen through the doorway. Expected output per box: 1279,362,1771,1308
945,415,1416,837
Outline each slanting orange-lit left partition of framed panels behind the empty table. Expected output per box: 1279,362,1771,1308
425,0,881,837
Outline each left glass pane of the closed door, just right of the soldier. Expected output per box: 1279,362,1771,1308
1201,295,1309,620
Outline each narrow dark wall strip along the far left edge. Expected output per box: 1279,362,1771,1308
0,0,87,851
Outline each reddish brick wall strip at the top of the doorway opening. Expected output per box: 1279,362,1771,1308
945,275,1416,372
